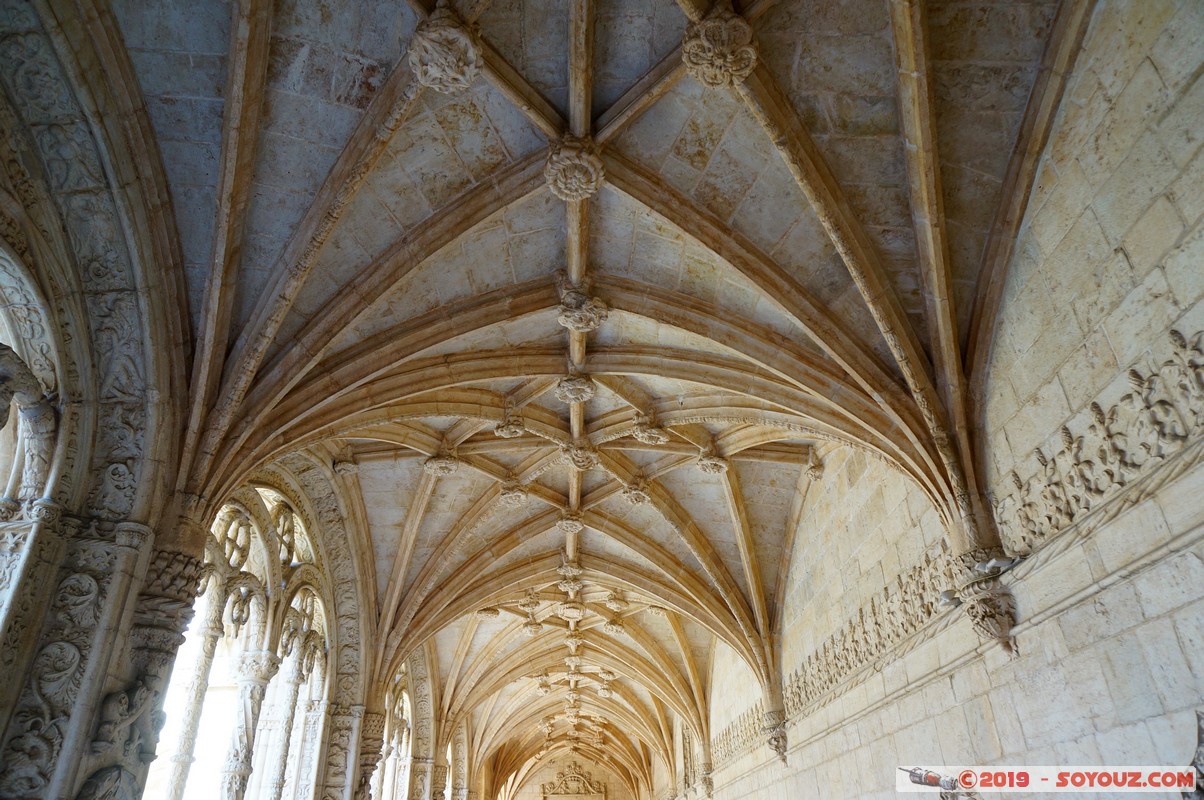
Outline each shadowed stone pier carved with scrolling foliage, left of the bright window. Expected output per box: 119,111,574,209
0,517,157,800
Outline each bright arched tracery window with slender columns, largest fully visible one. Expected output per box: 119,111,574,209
147,488,330,800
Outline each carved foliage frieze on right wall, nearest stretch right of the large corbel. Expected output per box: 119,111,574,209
996,330,1204,554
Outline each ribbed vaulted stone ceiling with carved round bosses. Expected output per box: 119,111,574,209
101,0,1058,789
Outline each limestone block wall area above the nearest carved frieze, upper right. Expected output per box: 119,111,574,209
981,0,1204,513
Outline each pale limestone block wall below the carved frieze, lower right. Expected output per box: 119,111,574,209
715,455,1204,800
